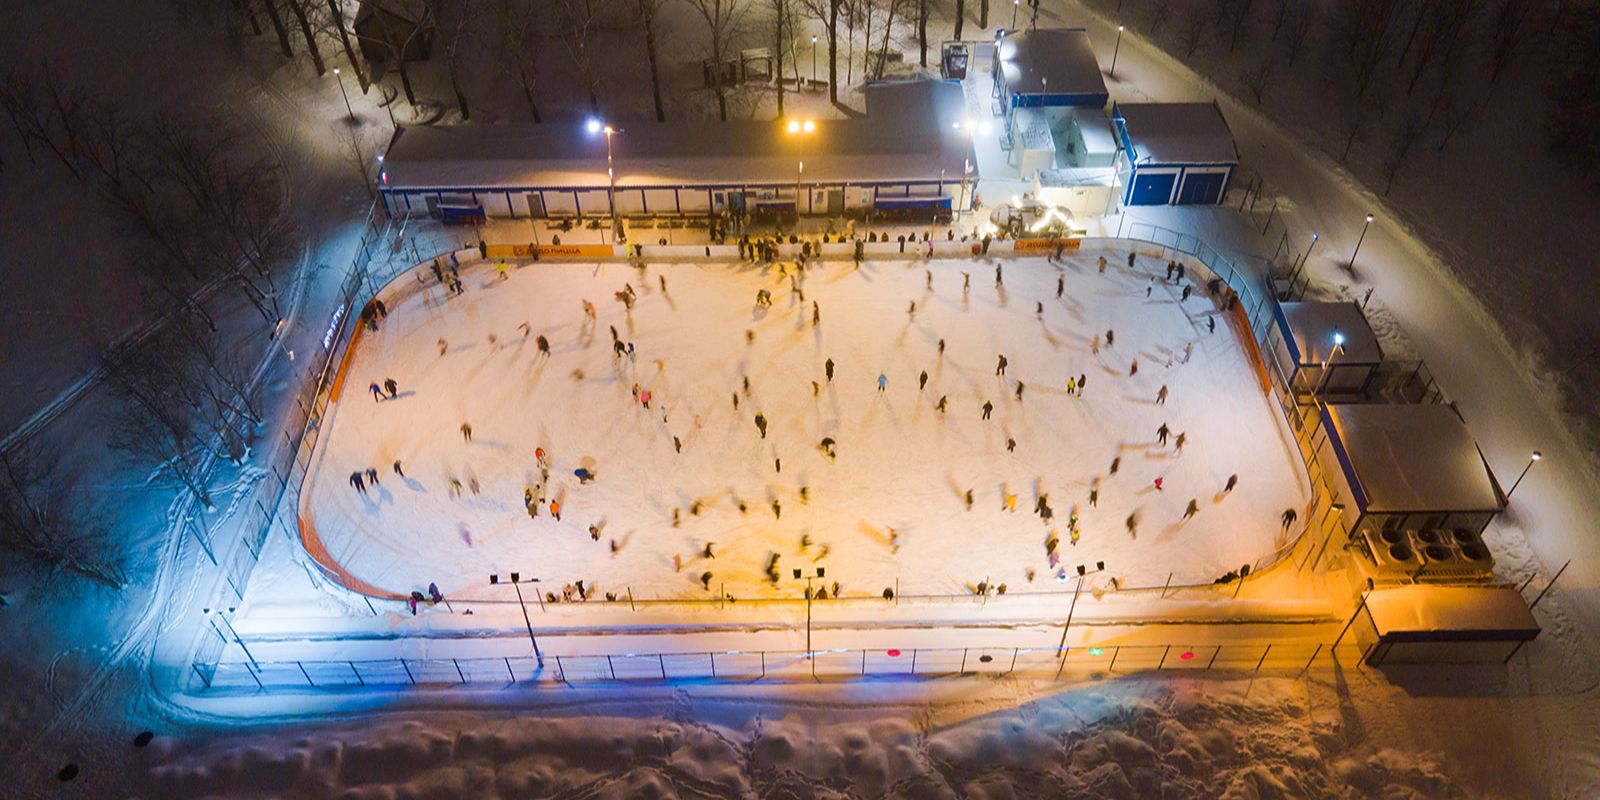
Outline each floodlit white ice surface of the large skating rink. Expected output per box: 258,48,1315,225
301,251,1309,598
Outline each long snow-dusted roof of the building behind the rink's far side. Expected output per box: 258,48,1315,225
384,80,971,189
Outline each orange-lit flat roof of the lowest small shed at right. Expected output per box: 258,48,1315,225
1366,586,1539,640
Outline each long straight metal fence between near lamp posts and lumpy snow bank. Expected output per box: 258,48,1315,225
194,640,1365,691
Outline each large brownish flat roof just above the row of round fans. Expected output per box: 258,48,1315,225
1323,403,1502,514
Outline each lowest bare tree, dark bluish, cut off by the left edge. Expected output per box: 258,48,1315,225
0,445,126,589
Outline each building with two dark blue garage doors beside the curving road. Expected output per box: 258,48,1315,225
1110,102,1238,205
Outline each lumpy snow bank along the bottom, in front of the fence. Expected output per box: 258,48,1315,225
136,678,1459,800
